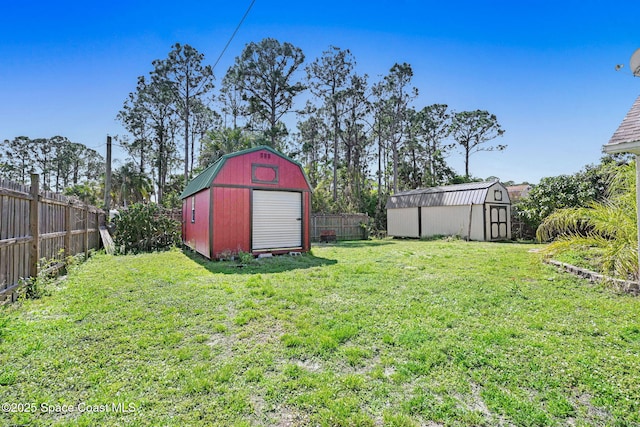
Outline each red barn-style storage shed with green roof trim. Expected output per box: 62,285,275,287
180,146,311,259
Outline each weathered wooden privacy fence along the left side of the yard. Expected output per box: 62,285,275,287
0,174,104,302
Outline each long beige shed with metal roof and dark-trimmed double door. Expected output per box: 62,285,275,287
387,181,511,241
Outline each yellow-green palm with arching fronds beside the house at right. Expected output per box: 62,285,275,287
536,163,638,279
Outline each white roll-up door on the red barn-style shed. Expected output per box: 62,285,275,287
251,190,302,250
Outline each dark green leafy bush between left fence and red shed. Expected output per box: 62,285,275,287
113,203,180,254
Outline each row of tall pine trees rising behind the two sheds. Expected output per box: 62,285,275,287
118,38,505,227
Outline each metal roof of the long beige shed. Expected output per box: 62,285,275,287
387,181,504,209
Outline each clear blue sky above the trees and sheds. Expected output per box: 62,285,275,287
0,0,640,183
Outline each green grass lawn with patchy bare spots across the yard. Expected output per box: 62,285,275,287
0,240,640,427
